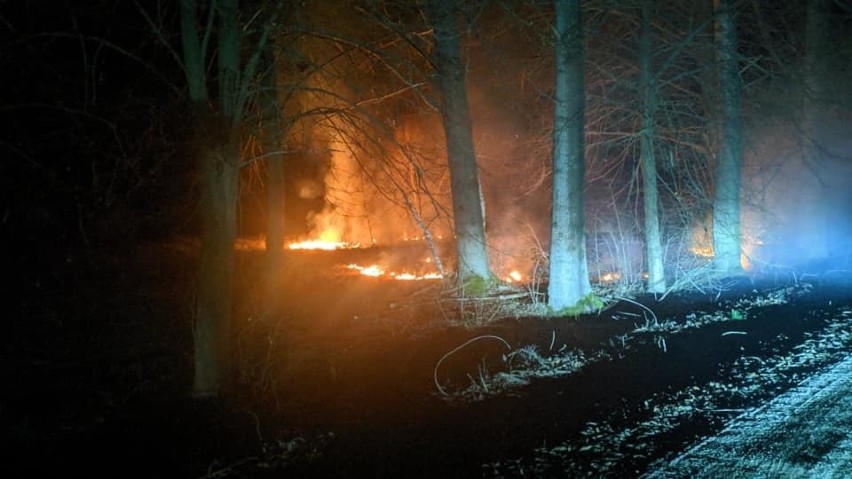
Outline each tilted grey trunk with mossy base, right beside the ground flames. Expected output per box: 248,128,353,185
426,0,491,284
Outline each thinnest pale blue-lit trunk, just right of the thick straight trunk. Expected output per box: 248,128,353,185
639,0,666,293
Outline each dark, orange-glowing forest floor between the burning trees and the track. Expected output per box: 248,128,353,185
5,245,852,477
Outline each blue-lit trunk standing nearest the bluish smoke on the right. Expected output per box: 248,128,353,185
713,0,742,276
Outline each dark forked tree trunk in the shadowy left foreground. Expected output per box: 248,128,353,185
180,0,274,397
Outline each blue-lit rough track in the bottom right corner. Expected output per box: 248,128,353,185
643,357,852,479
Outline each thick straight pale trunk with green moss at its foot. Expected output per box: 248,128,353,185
548,0,592,311
